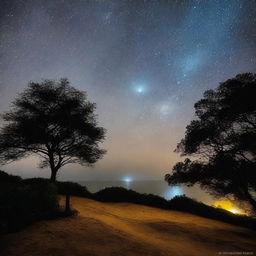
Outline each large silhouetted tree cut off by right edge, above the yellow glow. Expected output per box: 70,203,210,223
165,73,256,212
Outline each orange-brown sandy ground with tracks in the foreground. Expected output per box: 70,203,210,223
0,197,256,256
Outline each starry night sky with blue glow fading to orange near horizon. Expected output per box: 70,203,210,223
0,0,256,180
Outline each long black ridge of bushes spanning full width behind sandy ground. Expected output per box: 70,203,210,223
0,171,256,232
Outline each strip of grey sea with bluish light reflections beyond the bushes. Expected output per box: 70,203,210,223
79,180,216,205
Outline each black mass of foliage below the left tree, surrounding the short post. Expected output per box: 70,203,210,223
0,171,84,234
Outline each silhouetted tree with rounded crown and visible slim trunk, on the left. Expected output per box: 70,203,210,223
0,79,105,181
